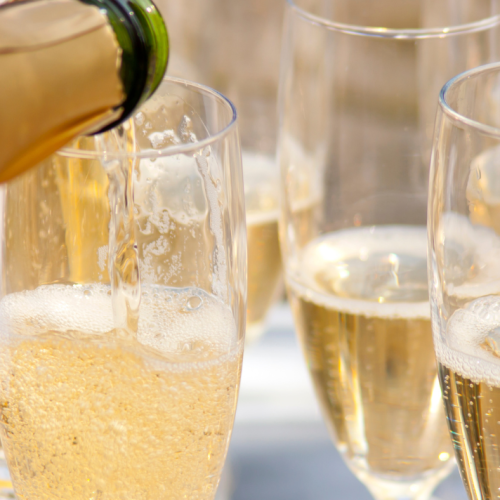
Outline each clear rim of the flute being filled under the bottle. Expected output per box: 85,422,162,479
55,76,238,160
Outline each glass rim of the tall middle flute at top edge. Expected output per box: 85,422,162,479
286,0,500,40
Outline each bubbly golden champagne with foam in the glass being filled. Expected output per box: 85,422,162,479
0,285,242,500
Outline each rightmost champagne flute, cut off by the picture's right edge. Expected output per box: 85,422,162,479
428,64,500,500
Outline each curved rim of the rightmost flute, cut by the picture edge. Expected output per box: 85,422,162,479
439,62,500,139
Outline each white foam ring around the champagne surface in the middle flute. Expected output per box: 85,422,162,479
287,225,430,319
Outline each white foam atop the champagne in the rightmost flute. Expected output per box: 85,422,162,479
433,295,500,386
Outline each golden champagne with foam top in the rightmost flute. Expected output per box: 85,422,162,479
435,295,500,500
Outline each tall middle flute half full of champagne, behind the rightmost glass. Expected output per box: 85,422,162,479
278,0,500,499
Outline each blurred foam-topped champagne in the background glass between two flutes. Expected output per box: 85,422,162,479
243,152,282,342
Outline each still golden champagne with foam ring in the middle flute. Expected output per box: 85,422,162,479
286,226,451,487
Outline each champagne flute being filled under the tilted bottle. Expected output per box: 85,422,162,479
0,79,246,500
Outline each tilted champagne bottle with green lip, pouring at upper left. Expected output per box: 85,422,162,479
0,0,168,182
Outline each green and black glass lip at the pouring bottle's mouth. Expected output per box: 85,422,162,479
81,0,169,132
